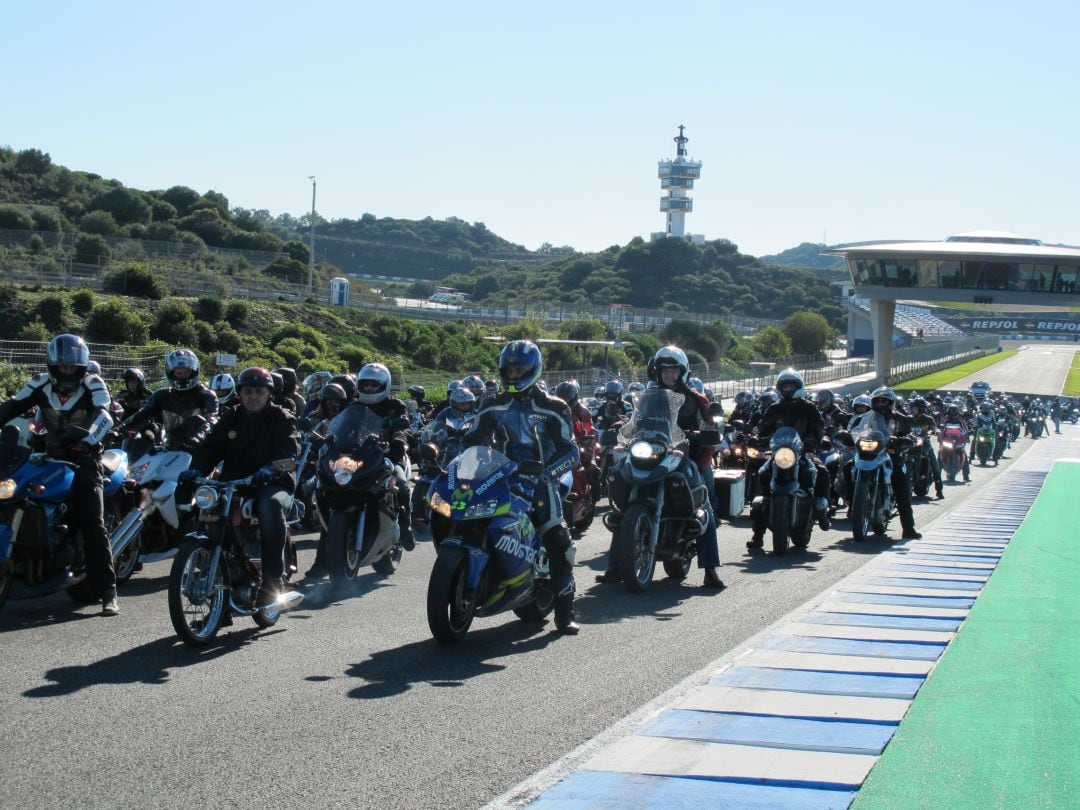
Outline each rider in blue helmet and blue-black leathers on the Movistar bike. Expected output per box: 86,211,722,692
462,340,581,635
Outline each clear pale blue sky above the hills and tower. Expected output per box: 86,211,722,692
0,0,1080,255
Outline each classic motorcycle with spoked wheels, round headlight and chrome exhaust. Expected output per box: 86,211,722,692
168,459,303,647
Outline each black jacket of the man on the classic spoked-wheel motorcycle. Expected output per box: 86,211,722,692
191,403,300,481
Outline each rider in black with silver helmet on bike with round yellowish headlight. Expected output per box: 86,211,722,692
746,368,832,549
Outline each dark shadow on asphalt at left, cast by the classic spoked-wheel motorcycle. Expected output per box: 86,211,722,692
23,627,274,698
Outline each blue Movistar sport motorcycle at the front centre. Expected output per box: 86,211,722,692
428,447,555,644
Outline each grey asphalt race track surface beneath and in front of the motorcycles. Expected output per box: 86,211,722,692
0,347,1067,809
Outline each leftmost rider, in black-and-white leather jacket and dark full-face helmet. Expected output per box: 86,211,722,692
0,335,120,616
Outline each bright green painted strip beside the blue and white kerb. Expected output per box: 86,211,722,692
852,462,1080,810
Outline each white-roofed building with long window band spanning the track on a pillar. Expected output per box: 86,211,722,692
827,231,1080,378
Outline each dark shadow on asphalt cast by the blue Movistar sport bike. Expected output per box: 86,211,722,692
336,621,558,700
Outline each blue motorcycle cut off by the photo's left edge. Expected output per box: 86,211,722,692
0,424,138,608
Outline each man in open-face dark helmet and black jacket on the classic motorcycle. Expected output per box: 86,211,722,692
180,366,300,608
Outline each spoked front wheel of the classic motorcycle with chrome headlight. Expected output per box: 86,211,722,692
168,540,227,647
